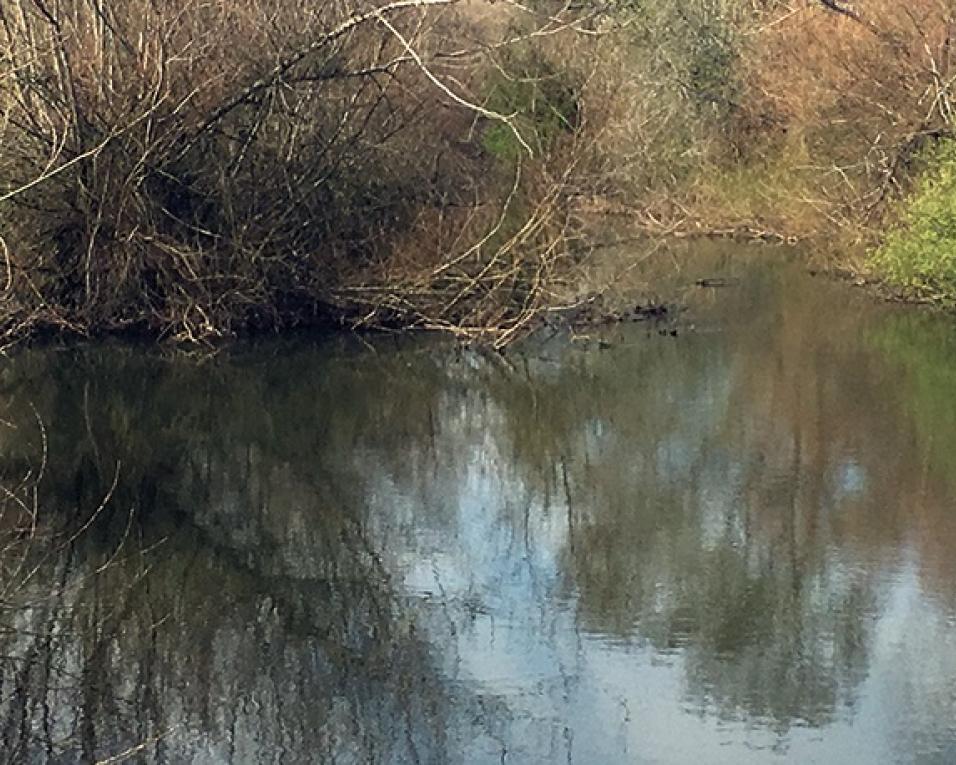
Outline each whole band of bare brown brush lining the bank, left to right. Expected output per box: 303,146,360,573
0,0,956,344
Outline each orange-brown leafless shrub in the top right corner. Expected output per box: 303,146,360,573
750,0,956,235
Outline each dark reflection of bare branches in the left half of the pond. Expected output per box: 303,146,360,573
0,348,478,762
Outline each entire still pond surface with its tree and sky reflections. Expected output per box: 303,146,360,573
0,248,956,765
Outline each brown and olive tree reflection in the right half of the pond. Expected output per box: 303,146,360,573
474,266,946,729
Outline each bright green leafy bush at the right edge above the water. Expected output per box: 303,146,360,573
870,141,956,305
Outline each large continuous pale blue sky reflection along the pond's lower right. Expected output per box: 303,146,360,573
382,484,956,765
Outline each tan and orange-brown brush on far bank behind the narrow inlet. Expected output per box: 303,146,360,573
580,0,956,264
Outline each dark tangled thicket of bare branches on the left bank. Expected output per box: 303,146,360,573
0,0,628,344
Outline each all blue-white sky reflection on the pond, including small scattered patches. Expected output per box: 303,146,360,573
360,374,956,765
